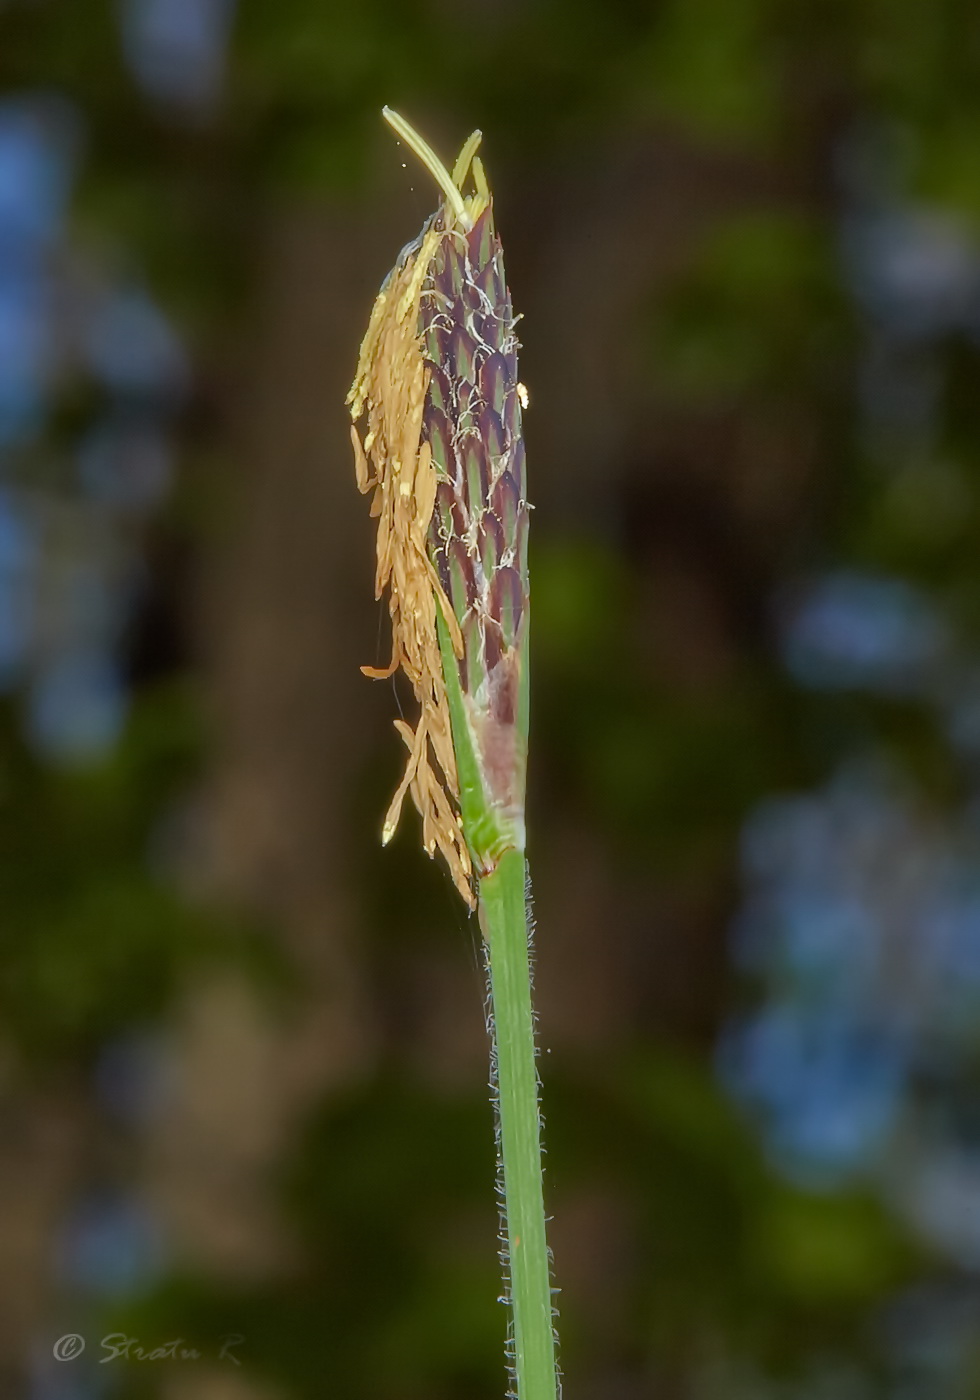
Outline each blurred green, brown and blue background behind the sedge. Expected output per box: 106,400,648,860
0,0,980,1400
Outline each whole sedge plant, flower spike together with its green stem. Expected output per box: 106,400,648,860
347,108,559,1400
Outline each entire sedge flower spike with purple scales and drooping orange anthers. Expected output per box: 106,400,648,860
349,113,529,904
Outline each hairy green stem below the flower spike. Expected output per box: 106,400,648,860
480,850,557,1400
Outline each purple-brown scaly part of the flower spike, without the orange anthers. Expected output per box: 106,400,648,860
421,204,528,844
